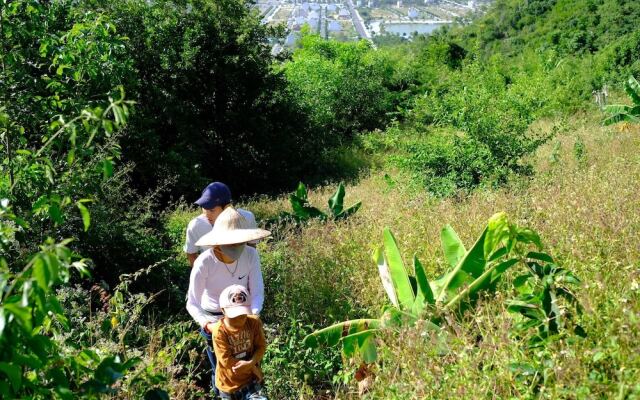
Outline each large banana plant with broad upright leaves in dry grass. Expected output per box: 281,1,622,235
303,213,542,363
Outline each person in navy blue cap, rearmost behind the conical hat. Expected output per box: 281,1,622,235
184,182,257,267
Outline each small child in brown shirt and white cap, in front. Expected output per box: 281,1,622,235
212,285,266,400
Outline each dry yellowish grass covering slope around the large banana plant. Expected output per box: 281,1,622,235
244,113,640,399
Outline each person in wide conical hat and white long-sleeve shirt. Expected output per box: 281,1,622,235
187,207,271,391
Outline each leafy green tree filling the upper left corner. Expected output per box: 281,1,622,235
0,0,136,264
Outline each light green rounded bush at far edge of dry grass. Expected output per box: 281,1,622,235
407,58,553,188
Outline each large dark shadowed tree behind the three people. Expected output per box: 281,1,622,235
94,0,323,198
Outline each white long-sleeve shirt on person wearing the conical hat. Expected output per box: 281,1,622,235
187,246,264,327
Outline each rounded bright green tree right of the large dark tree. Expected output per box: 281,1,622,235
283,34,393,140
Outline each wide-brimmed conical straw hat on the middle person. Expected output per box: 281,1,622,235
196,207,271,246
